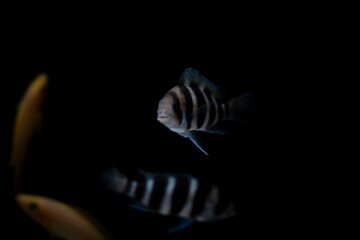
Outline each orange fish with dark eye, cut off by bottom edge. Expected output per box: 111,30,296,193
16,194,112,240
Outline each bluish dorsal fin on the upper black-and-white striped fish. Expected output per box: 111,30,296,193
179,68,224,99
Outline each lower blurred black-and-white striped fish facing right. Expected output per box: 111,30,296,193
101,167,236,233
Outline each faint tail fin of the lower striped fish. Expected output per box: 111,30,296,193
100,167,128,193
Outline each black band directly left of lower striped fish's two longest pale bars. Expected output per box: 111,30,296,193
149,175,168,210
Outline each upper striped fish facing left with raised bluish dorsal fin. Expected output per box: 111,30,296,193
157,68,253,155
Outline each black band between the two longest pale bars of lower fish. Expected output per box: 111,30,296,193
170,176,190,214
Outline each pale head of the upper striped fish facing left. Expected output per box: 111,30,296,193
157,94,181,129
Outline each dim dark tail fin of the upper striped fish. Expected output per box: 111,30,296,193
225,92,255,123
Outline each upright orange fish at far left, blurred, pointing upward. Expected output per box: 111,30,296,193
9,73,48,192
